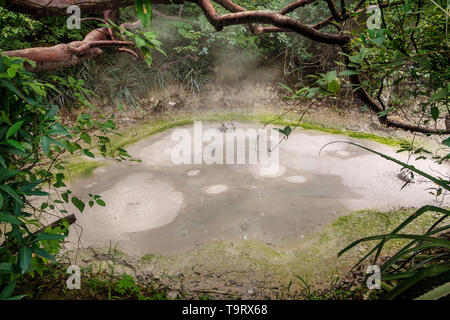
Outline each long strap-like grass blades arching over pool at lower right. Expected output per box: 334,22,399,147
339,143,450,299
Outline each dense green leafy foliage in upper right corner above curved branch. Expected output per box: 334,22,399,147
340,0,450,124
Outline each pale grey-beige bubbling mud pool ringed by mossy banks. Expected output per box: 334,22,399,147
69,123,442,255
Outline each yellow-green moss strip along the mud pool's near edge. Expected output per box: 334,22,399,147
134,209,442,298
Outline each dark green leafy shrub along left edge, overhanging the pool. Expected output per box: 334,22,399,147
0,55,134,298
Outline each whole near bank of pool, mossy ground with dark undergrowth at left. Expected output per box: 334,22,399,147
17,209,442,299
